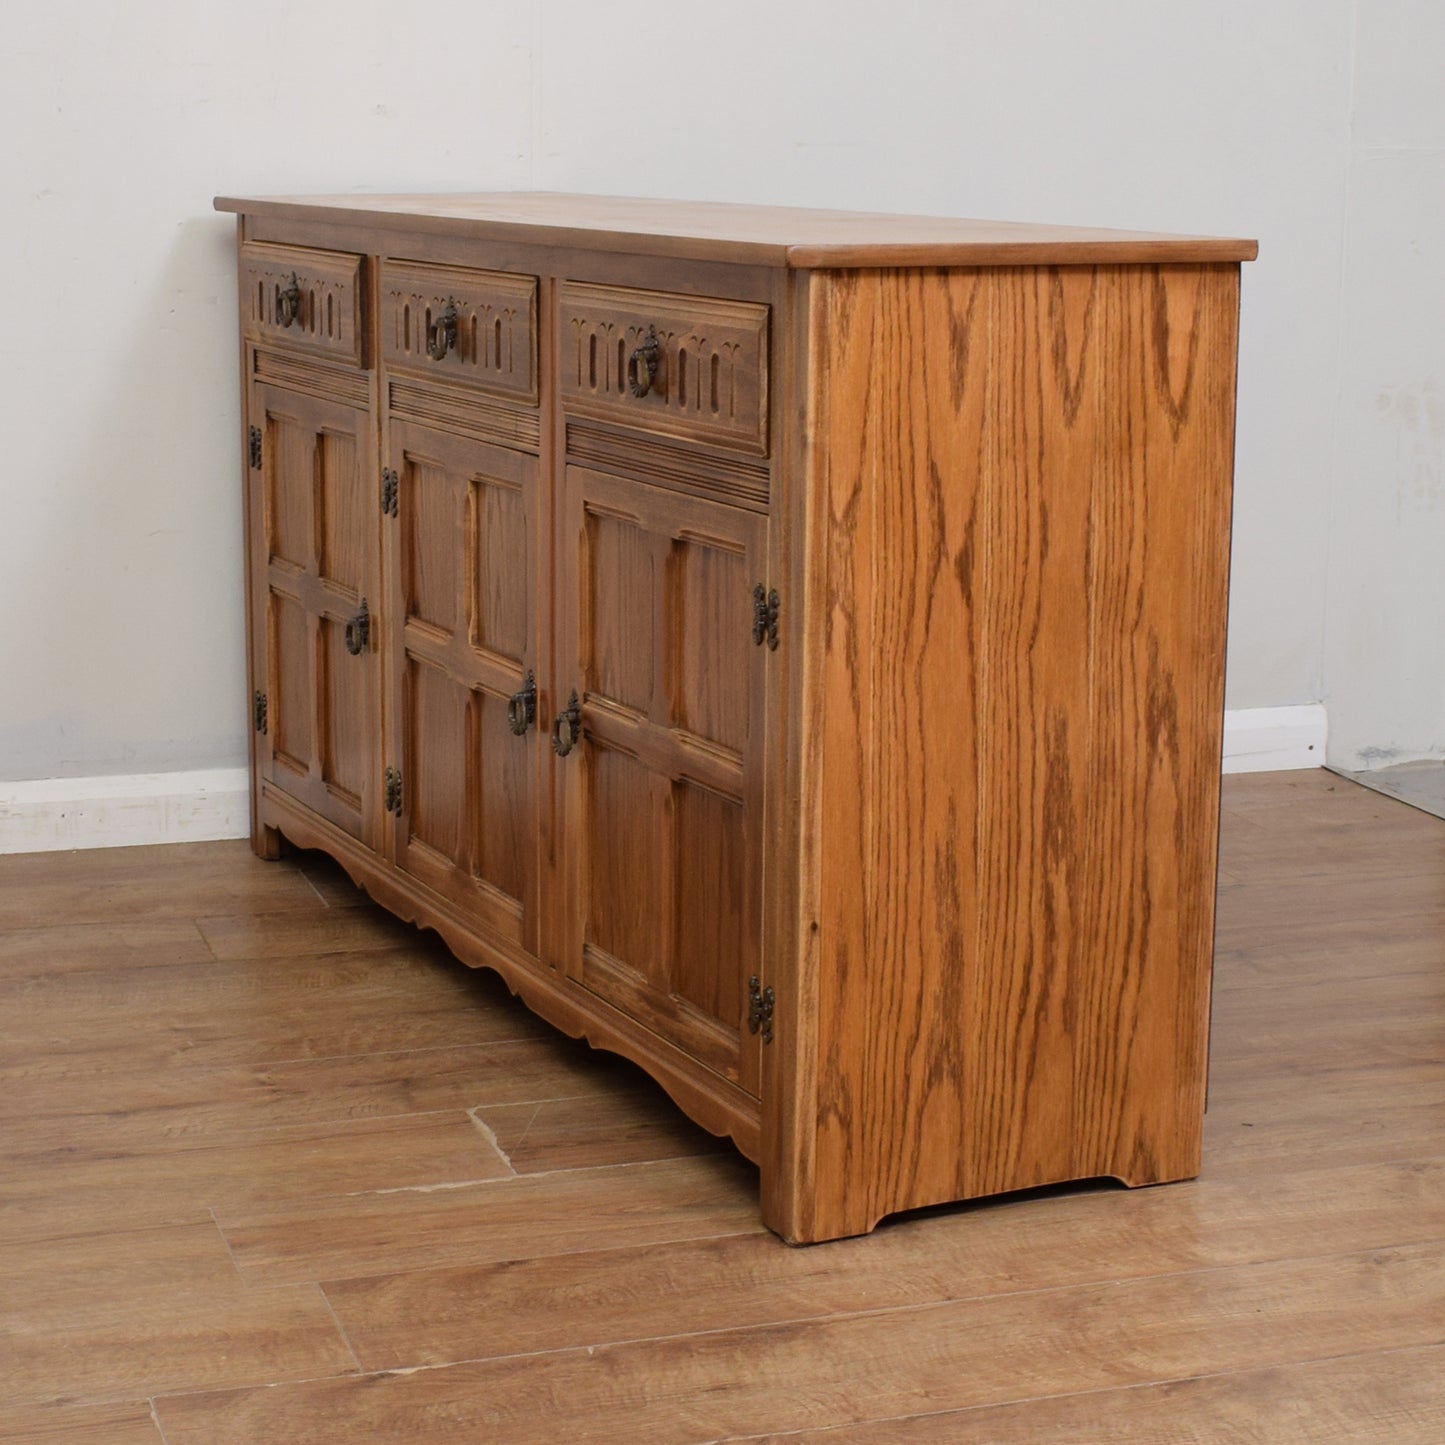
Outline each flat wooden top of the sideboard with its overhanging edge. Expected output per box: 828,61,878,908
215,191,1257,269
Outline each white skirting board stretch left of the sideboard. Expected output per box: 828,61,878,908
0,767,251,853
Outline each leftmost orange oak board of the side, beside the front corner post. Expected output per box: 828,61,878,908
811,272,987,1238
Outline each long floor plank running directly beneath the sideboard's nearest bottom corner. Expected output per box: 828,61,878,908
327,1150,1442,1370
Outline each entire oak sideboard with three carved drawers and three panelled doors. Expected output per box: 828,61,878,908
217,194,1254,1241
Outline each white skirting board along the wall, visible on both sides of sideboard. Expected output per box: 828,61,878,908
0,705,1325,853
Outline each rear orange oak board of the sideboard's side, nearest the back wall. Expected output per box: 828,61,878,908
1074,266,1238,1183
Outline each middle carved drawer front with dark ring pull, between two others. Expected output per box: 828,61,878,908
381,262,538,403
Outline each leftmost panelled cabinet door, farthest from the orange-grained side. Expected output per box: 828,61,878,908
250,386,380,844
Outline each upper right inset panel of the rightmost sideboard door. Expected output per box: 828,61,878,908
666,538,753,753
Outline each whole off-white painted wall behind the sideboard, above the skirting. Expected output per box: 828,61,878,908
0,0,1445,797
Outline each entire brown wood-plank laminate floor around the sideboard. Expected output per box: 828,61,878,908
0,772,1445,1445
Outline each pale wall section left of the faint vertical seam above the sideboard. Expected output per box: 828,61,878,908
0,0,533,780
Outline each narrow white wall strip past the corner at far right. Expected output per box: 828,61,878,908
1324,0,1445,767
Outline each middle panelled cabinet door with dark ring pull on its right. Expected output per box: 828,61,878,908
384,422,539,954
